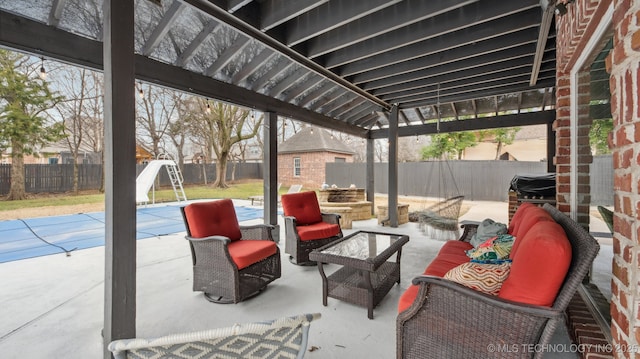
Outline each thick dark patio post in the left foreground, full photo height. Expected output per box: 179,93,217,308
103,0,136,358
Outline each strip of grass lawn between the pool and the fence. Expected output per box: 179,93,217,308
0,180,287,215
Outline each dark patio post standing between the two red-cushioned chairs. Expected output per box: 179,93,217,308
262,112,280,240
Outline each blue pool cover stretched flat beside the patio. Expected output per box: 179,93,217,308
0,204,264,263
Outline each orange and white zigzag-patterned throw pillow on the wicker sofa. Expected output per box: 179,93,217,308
444,262,511,295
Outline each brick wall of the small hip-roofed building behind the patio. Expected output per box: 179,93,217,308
278,152,353,189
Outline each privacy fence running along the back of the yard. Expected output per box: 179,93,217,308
0,156,613,206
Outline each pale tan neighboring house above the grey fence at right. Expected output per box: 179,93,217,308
464,125,547,161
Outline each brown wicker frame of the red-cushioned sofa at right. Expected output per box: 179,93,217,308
396,204,599,358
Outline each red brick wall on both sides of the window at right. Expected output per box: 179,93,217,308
554,0,640,358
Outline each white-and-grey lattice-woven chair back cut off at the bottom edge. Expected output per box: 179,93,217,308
108,314,320,359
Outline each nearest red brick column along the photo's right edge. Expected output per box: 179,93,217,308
607,0,640,358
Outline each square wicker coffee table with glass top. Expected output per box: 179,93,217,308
309,231,409,319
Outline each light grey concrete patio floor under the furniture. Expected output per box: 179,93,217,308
0,201,612,359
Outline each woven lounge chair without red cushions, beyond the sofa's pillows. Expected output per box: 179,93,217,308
418,196,464,240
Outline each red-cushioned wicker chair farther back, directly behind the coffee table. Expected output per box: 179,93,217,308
282,191,342,265
